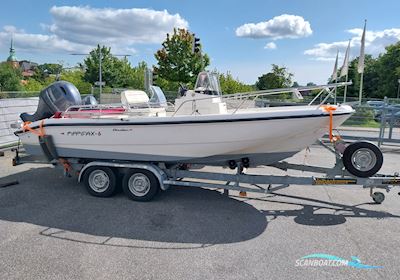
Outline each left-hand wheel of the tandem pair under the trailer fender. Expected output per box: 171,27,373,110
83,166,117,197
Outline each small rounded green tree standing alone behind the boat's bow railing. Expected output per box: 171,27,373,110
256,64,293,90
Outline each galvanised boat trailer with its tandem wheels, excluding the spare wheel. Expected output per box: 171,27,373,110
13,141,400,204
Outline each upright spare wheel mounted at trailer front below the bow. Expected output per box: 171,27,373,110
342,142,383,178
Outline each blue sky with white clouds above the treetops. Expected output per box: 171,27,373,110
0,0,400,84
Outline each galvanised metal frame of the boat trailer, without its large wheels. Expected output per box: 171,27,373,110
13,141,400,204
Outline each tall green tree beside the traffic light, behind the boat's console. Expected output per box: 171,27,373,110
154,29,210,84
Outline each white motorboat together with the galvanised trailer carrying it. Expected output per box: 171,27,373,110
14,72,398,201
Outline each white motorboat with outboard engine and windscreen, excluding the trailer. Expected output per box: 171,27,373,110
15,72,354,166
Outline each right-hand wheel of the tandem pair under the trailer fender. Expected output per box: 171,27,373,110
122,169,160,201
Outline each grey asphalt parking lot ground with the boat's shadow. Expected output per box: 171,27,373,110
0,146,400,279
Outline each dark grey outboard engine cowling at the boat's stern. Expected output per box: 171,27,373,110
20,81,81,122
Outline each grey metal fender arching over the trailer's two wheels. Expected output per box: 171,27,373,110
78,161,169,191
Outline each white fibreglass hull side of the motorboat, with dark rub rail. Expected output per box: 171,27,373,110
17,105,352,166
